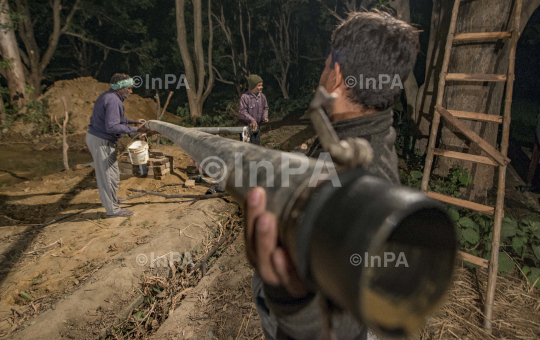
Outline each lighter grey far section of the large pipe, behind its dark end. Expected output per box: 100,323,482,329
146,120,317,216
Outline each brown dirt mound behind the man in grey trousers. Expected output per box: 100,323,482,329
42,77,180,133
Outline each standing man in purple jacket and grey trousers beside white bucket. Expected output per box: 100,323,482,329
86,73,148,217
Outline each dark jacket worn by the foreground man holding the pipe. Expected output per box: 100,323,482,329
252,109,400,340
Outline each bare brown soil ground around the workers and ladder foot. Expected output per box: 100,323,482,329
0,115,540,340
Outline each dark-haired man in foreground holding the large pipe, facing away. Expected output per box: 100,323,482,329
245,12,419,340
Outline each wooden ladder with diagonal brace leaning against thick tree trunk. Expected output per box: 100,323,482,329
421,0,522,333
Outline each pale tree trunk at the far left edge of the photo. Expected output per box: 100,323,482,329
0,0,26,106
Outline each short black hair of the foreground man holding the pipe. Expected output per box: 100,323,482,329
331,11,420,111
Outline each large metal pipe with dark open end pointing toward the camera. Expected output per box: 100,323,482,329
147,121,457,336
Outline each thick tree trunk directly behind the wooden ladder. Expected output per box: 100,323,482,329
416,0,540,202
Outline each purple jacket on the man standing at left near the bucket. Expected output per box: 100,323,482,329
88,89,137,144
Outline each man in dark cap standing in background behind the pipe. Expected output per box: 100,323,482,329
238,74,268,145
